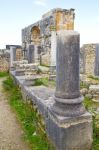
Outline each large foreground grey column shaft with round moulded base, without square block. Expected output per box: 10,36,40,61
53,31,85,117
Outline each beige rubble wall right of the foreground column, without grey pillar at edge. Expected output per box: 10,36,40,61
81,44,96,75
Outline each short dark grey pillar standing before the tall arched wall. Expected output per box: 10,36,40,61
28,44,35,63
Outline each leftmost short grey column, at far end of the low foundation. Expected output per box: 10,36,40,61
10,46,16,67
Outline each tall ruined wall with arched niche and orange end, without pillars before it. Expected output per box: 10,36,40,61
22,8,75,65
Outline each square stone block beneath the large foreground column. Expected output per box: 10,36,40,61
46,111,93,150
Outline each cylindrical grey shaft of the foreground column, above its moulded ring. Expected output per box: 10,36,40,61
55,31,80,99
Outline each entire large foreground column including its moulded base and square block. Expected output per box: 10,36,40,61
46,31,92,150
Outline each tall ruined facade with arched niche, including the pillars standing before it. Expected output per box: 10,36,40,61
22,8,75,66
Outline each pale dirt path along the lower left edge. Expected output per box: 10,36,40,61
0,79,29,150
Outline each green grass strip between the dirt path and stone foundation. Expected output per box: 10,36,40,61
3,77,54,150
